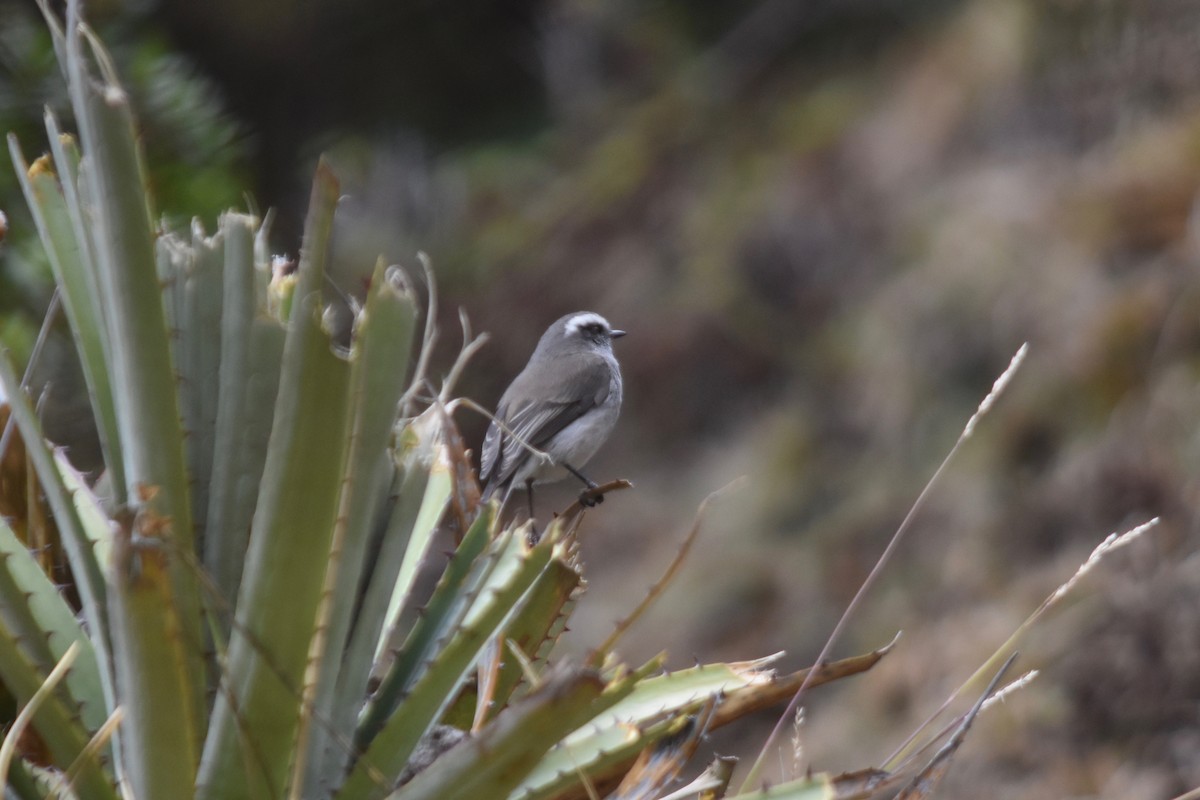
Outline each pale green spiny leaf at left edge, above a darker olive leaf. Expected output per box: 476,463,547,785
0,519,107,732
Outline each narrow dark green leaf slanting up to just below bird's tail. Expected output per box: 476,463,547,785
355,507,494,748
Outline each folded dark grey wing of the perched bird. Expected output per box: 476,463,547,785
480,355,611,487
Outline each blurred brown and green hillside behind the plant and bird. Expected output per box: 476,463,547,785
0,0,1200,800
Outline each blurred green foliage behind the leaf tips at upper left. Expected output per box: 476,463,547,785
0,0,251,354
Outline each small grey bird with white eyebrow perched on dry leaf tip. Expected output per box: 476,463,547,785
479,311,625,517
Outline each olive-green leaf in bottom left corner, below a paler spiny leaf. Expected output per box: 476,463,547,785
0,618,118,800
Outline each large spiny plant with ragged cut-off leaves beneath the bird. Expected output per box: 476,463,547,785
0,4,881,800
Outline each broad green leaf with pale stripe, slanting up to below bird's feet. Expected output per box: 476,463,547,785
337,529,551,800
